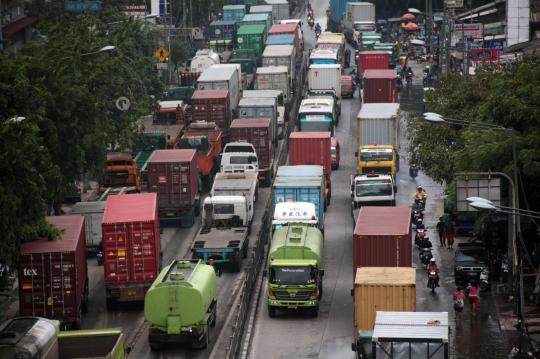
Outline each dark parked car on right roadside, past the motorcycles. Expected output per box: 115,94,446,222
454,242,489,285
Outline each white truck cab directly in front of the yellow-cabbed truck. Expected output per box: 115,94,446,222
351,174,396,210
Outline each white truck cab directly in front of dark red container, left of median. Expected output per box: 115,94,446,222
220,142,259,173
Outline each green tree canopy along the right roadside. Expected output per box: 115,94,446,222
408,57,540,210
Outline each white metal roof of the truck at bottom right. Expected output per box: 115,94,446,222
373,311,449,342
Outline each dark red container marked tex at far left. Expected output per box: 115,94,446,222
19,215,88,325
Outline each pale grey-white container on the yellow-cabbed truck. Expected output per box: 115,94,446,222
356,103,399,148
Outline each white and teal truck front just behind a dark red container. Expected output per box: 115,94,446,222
298,98,336,136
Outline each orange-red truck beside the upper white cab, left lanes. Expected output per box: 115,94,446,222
177,121,222,189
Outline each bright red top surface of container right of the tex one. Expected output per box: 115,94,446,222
102,193,157,224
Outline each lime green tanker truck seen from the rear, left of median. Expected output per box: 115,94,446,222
144,259,217,350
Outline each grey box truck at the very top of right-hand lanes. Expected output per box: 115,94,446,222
342,2,376,47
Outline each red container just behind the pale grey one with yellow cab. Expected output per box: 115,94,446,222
362,70,398,103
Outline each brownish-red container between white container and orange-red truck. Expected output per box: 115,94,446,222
191,90,232,138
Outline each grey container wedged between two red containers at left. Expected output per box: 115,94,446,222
71,201,106,254
